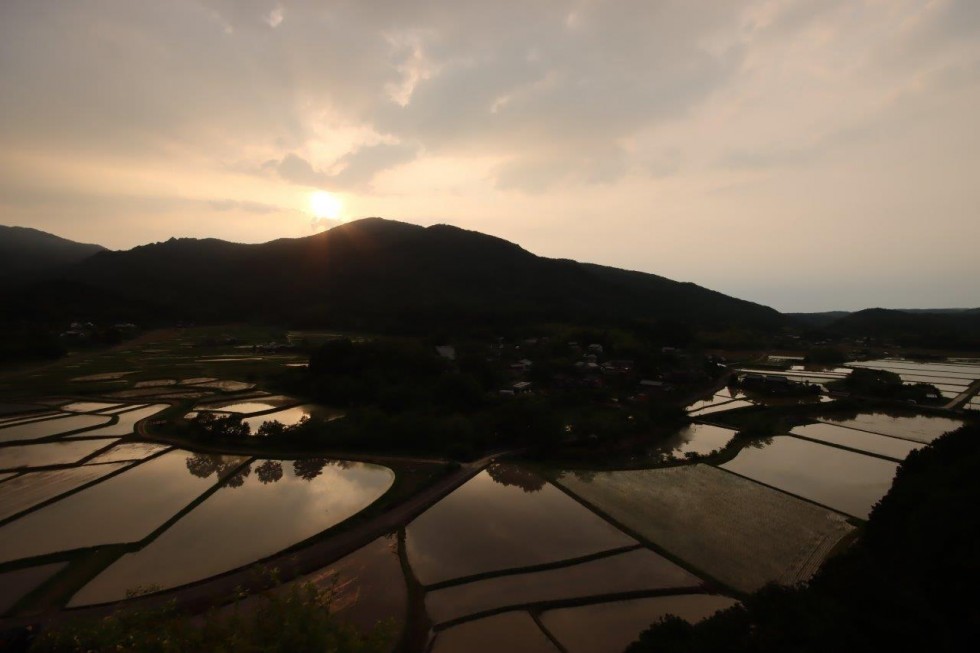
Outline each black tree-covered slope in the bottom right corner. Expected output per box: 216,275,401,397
628,424,980,653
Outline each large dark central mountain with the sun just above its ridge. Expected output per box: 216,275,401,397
0,218,784,331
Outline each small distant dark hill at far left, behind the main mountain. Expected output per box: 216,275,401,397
0,225,105,281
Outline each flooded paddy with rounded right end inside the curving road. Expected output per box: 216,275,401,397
68,452,394,607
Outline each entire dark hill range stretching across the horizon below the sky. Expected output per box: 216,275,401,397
0,218,980,348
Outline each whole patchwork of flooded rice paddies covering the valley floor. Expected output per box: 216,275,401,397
0,333,980,653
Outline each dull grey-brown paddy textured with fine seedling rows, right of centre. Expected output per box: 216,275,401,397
558,464,853,592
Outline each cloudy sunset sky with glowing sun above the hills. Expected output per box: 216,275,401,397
0,0,980,311
